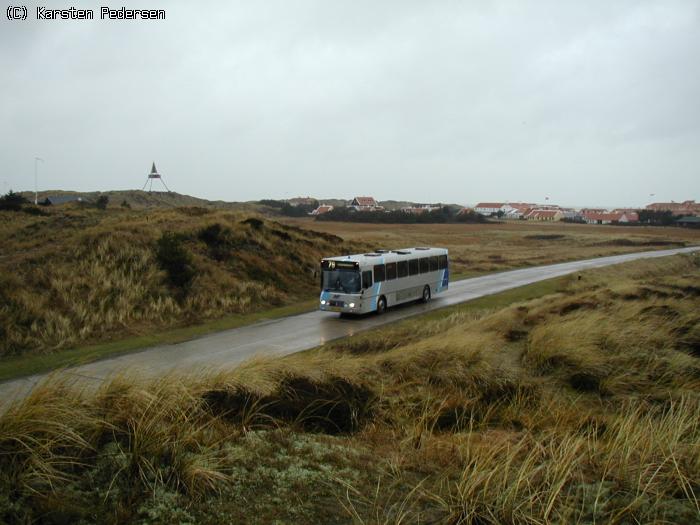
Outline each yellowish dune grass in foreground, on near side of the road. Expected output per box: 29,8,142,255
0,256,700,524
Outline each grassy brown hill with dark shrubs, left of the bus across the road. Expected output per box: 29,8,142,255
0,205,359,358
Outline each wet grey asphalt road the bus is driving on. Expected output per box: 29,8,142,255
0,246,700,406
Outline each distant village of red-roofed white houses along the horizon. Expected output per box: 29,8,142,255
296,197,700,226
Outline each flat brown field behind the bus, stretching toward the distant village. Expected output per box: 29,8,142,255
281,218,700,277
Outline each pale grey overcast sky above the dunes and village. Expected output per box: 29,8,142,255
0,0,700,206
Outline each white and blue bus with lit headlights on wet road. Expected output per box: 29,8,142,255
320,247,450,314
